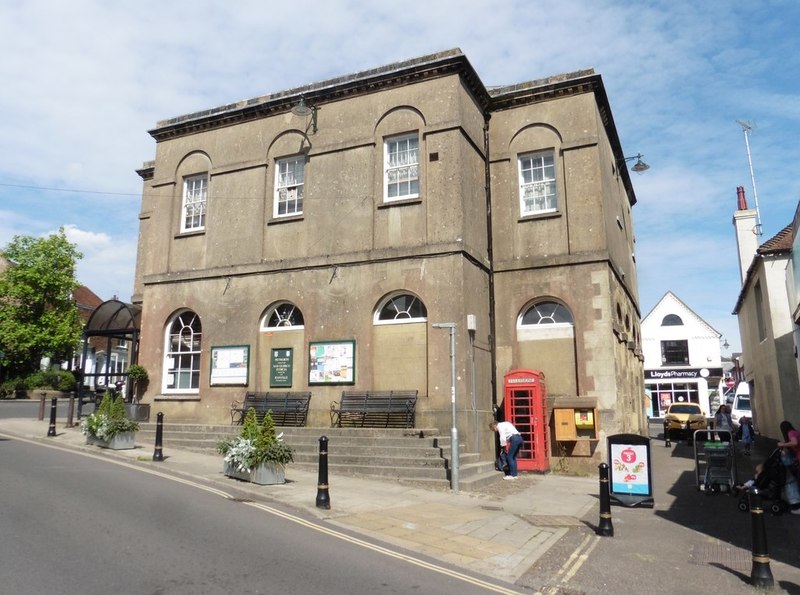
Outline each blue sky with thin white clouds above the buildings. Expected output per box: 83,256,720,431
0,0,800,351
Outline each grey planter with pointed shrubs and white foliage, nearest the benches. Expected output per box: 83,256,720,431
217,408,294,485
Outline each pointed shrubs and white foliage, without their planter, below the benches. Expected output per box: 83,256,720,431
217,408,294,472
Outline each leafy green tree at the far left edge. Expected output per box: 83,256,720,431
0,227,83,378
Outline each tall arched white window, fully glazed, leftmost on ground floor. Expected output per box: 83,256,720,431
164,310,203,393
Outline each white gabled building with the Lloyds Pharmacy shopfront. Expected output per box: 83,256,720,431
642,291,723,417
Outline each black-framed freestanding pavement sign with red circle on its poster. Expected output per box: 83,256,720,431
608,434,654,508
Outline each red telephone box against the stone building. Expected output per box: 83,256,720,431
503,370,550,471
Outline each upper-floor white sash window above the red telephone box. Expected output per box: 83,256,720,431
517,149,558,217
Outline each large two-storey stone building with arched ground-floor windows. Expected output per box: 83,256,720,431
133,49,645,469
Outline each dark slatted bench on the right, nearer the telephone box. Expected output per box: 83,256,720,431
331,390,417,428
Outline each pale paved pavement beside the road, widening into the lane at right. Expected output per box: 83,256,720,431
0,419,800,595
